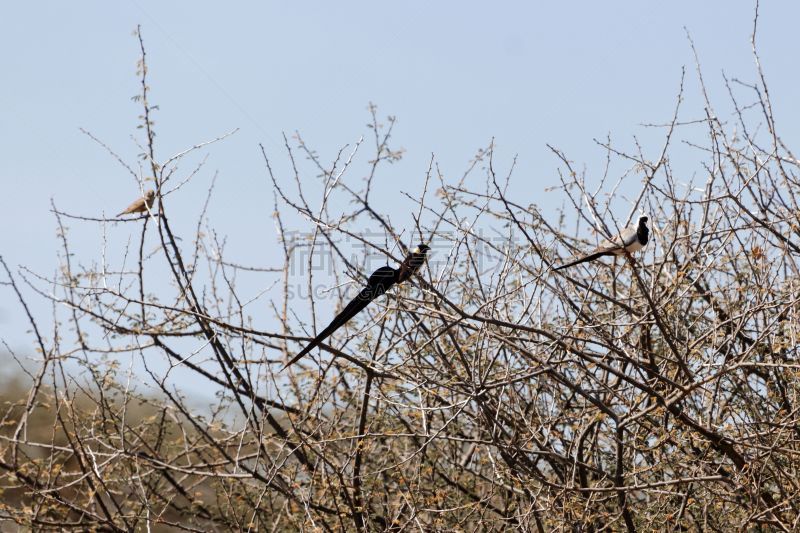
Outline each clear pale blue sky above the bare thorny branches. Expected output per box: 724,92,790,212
0,0,800,400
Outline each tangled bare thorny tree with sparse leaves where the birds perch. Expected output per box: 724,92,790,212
0,14,800,531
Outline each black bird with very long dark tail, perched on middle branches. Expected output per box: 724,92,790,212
282,244,430,370
